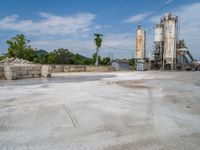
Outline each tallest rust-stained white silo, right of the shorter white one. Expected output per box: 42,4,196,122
161,13,178,69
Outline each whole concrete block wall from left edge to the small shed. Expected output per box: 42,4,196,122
0,64,112,80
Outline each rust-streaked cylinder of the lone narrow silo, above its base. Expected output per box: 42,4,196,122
136,26,146,59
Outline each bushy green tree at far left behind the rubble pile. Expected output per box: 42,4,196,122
6,34,35,61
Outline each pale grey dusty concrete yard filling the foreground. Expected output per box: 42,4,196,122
0,72,200,150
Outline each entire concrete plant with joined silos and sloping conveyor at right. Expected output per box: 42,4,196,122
149,13,194,70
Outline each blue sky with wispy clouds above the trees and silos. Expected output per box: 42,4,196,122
0,0,200,59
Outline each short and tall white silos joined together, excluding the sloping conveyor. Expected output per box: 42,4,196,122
152,13,178,70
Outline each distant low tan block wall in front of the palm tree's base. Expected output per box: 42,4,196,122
51,65,112,73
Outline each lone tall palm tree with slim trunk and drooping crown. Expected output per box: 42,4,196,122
94,33,103,66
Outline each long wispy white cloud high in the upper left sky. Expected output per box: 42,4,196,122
0,12,96,35
